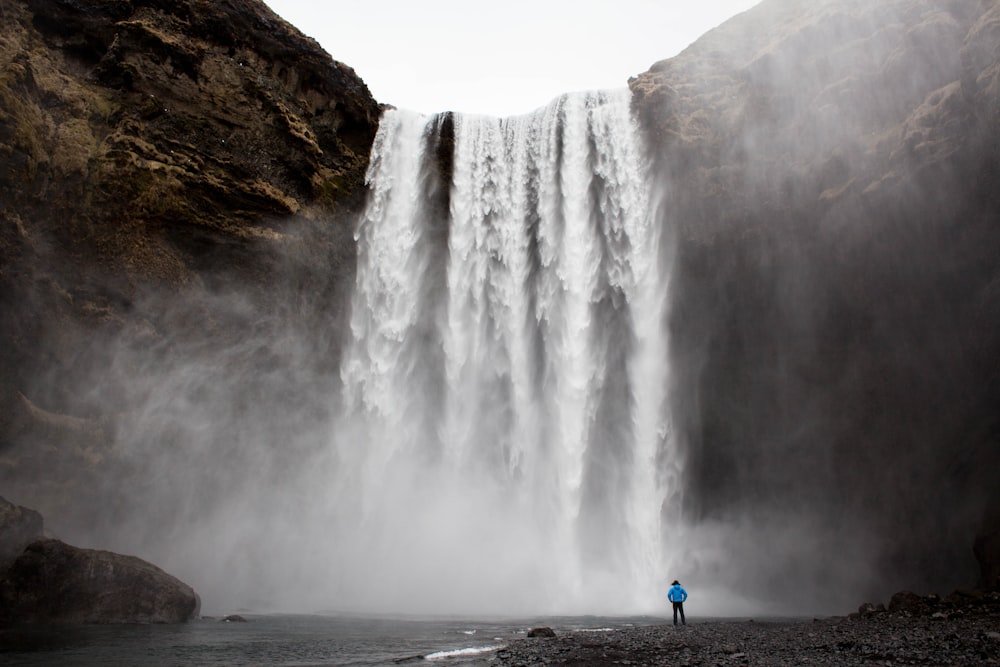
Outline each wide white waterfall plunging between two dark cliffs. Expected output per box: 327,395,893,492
329,90,677,613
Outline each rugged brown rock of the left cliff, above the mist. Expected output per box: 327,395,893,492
0,0,379,376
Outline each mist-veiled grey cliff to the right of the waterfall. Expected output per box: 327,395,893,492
630,0,1000,595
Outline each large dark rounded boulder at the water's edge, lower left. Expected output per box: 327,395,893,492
0,539,201,624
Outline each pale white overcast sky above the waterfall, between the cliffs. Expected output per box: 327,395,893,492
265,0,759,116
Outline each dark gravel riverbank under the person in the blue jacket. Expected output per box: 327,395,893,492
495,593,1000,667
